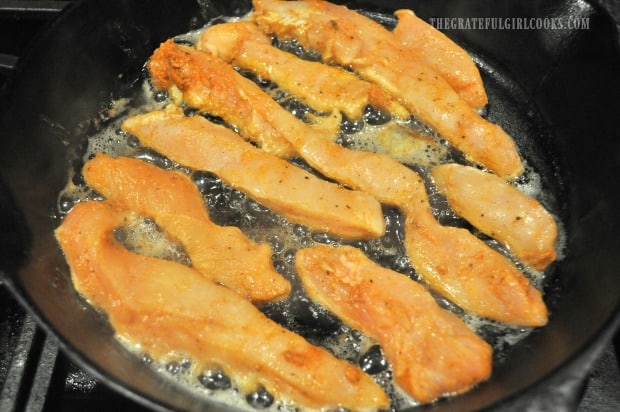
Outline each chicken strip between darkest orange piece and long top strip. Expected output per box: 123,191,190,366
196,21,409,119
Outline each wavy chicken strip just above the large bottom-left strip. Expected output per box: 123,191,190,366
83,154,291,303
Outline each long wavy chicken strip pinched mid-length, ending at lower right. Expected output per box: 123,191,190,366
225,87,547,326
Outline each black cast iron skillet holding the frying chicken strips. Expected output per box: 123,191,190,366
0,0,620,410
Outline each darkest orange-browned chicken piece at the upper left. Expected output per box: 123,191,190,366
147,40,295,158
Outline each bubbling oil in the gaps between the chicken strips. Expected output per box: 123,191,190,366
58,9,562,411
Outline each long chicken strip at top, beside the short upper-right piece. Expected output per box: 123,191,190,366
252,0,523,178
